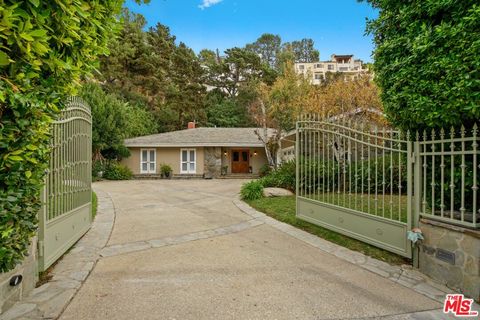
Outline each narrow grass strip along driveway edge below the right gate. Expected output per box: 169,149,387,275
247,196,409,265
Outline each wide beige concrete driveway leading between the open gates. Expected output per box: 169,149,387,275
58,180,440,319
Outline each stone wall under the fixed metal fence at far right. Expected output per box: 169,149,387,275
419,219,480,301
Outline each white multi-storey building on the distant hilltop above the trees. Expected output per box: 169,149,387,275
295,54,368,84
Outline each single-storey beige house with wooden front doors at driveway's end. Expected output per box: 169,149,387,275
121,122,272,178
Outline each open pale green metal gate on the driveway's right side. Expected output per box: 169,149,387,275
296,117,413,258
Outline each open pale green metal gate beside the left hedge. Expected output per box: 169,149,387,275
38,98,92,271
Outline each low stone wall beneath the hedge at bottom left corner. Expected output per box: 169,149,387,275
0,237,38,314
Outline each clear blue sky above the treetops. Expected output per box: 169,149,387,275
126,0,377,62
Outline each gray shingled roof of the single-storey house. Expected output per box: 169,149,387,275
125,128,273,147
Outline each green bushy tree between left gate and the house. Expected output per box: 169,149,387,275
80,83,156,160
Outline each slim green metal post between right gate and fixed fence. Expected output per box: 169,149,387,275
409,133,422,268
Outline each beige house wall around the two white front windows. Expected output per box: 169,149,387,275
121,147,204,175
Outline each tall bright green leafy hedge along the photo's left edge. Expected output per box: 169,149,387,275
0,0,141,271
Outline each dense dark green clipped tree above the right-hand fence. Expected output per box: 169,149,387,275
367,0,480,130
